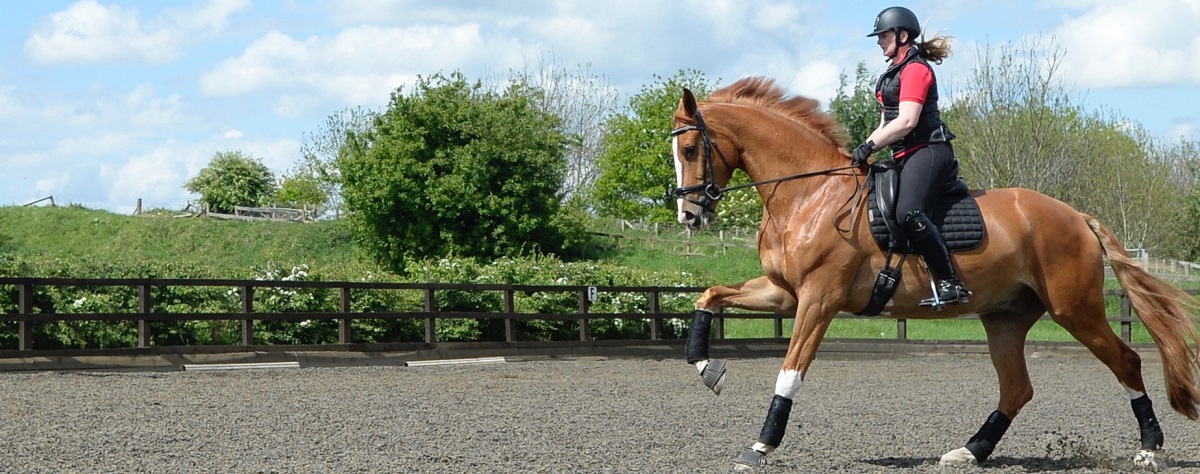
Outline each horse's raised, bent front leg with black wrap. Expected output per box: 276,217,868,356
684,276,796,395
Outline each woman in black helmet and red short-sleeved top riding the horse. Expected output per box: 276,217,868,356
852,6,971,306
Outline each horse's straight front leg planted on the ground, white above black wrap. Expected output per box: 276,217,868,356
733,289,838,470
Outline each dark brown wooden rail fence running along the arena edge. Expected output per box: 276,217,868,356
0,277,1198,350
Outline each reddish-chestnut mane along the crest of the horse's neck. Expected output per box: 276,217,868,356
706,77,848,151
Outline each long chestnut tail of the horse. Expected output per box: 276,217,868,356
1084,215,1200,420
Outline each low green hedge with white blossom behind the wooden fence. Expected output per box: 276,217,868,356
0,254,696,349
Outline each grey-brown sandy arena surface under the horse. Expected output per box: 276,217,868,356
0,354,1200,474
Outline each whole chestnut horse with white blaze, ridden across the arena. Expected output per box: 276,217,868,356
672,78,1200,470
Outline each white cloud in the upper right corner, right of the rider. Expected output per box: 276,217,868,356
1054,0,1200,88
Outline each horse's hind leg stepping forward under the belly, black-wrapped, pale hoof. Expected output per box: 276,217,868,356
938,306,1043,466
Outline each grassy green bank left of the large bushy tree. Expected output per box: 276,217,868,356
0,206,373,278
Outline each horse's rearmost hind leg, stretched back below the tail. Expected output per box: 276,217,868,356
1050,292,1163,467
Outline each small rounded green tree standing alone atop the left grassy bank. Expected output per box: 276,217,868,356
184,151,275,212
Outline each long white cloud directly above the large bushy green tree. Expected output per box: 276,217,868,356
200,24,522,112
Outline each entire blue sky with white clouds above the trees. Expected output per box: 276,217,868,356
0,0,1200,212
